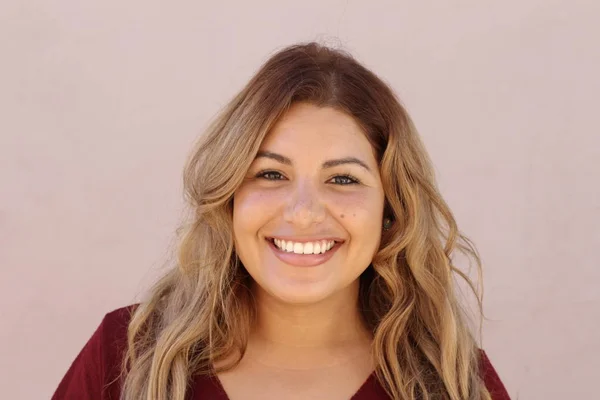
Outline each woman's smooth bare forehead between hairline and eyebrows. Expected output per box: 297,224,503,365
261,103,374,157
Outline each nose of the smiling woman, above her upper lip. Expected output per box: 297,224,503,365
284,180,325,229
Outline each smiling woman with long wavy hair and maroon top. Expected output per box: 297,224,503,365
54,43,508,400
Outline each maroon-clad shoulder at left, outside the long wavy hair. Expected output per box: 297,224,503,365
52,304,138,400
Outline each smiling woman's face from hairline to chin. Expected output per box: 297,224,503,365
233,103,384,304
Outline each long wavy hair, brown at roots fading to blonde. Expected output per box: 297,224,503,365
122,43,490,400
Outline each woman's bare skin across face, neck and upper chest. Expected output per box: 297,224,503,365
219,103,384,400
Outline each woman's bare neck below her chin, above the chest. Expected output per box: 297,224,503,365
248,282,372,368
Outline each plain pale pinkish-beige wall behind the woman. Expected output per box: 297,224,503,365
0,0,600,400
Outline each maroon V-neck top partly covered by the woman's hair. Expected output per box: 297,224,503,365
52,306,510,400
